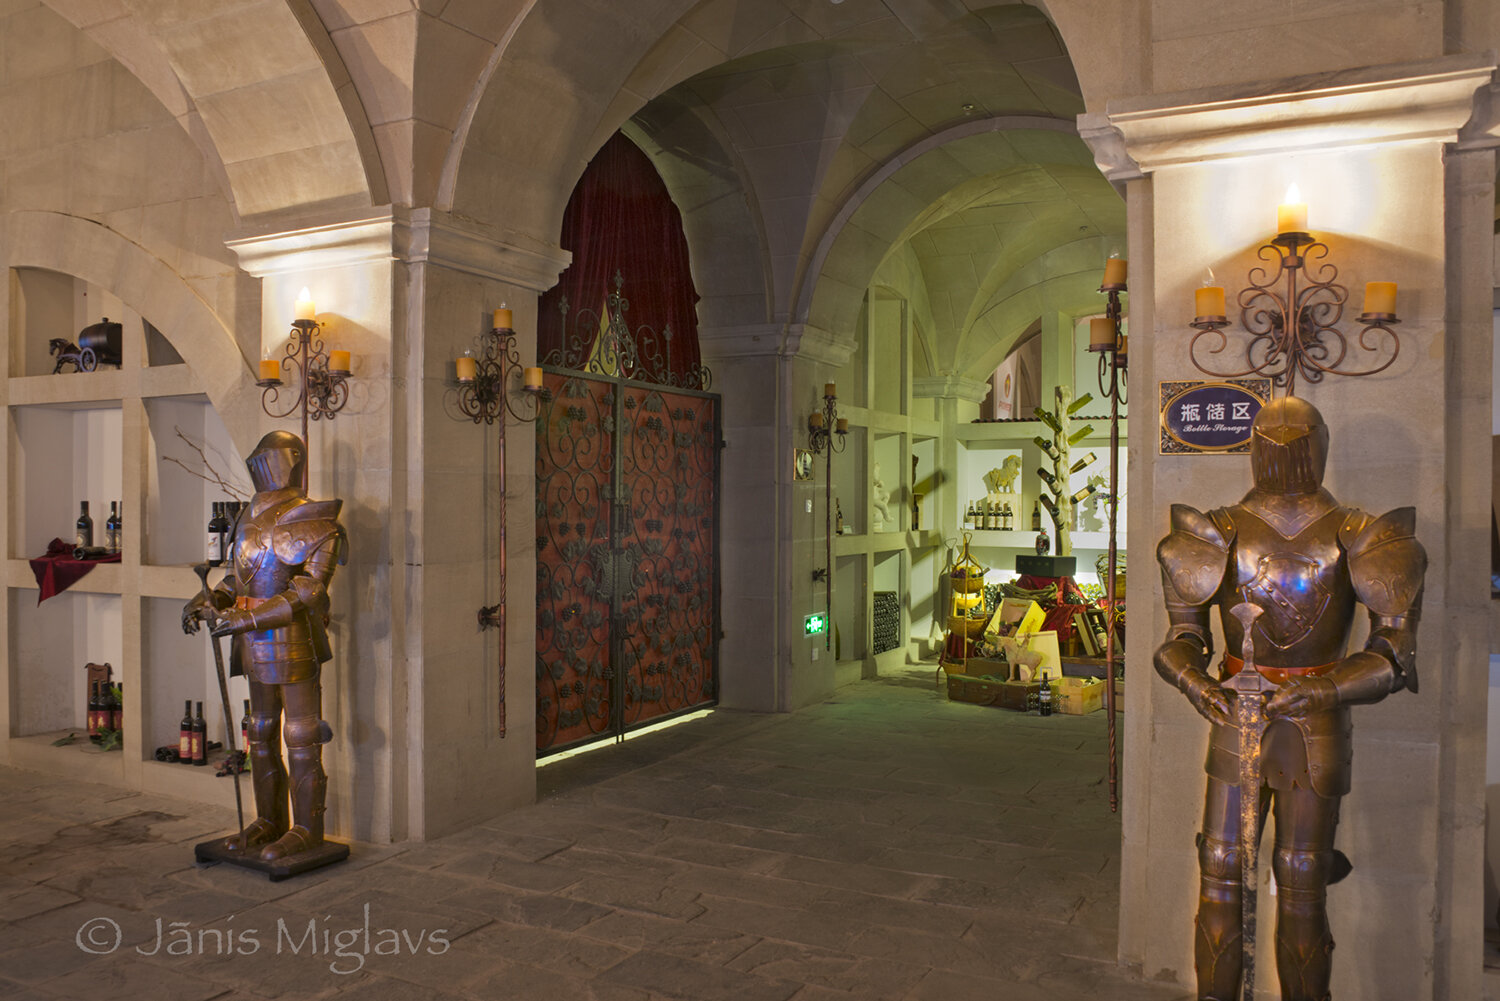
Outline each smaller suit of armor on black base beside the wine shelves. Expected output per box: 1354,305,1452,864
183,431,345,860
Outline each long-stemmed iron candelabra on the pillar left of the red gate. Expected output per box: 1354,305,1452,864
455,313,546,737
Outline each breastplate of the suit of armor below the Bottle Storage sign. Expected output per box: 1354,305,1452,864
1209,504,1356,668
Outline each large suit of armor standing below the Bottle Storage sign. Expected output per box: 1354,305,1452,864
1155,398,1427,1001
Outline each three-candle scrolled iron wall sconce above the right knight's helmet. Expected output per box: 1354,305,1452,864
1188,185,1401,395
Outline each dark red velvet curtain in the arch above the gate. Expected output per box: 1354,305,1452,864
537,132,699,377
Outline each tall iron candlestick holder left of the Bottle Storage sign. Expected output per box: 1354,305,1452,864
1089,271,1128,812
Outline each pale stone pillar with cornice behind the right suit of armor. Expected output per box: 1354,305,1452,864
1080,57,1494,999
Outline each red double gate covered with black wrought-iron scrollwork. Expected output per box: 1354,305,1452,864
537,358,720,756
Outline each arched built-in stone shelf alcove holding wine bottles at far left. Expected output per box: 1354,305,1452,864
0,269,249,804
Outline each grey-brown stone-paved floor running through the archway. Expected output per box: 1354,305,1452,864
0,668,1188,1001
